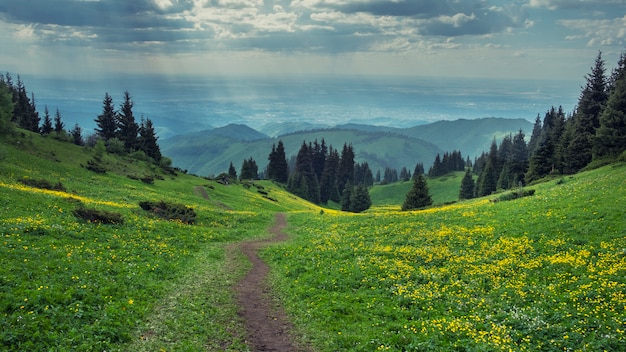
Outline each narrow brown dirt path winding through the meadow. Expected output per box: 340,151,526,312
235,213,308,352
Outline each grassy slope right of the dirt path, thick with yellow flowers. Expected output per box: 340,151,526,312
265,164,626,351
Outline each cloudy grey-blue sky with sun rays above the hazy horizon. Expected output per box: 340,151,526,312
0,0,626,81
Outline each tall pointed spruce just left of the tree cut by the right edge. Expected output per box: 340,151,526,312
566,52,608,172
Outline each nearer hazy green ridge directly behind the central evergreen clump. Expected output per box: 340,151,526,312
162,129,440,175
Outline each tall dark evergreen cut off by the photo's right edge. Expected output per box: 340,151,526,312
593,53,626,159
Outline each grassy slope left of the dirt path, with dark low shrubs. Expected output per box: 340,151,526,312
0,133,319,351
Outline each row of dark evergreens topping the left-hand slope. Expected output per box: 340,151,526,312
0,73,163,163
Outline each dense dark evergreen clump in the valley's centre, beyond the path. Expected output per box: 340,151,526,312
266,139,374,212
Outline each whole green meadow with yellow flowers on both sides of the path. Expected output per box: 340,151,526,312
0,130,626,351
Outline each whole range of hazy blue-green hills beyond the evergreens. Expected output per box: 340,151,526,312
159,117,533,176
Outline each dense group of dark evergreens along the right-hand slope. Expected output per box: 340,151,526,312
460,53,626,199
